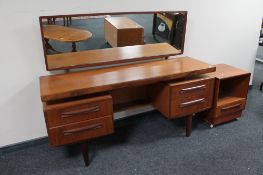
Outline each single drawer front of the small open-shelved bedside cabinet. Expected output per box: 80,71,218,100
216,99,246,117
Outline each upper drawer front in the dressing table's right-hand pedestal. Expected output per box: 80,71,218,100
171,79,214,99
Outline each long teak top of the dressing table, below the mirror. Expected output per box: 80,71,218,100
40,57,215,102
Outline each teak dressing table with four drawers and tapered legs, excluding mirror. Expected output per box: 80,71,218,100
40,46,249,165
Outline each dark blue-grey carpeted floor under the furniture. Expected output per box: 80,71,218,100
0,63,263,175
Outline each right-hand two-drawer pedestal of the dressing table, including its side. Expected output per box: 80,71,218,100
150,76,215,119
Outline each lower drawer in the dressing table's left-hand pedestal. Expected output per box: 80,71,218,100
48,116,113,146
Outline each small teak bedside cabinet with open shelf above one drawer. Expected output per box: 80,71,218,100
204,64,250,128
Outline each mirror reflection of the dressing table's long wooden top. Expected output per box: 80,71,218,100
47,43,181,70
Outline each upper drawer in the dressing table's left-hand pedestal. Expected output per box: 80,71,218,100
44,95,113,128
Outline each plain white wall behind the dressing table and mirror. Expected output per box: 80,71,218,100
0,0,263,147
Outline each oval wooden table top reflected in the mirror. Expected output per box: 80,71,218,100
43,25,92,42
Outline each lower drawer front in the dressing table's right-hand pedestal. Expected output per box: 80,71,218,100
171,94,212,118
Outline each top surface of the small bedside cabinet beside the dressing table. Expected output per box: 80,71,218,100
207,64,250,80
